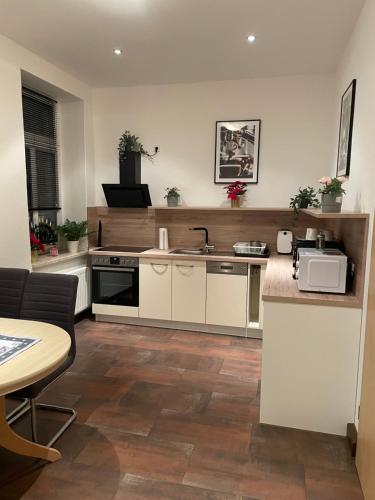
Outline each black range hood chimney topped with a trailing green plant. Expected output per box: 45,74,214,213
117,130,157,184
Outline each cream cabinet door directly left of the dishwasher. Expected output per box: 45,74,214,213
172,261,206,323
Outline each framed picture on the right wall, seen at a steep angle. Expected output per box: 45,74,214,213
337,80,357,177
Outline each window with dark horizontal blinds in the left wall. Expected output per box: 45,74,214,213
22,88,60,224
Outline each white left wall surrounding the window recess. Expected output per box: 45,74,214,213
0,35,94,267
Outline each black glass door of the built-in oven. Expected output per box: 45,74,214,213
92,266,139,307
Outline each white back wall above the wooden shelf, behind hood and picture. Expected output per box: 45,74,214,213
93,75,335,207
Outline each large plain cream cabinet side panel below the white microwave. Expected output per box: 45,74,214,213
260,301,362,436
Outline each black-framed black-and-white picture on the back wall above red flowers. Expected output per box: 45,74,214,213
215,120,260,184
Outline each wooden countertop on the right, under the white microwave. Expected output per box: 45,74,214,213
263,254,362,309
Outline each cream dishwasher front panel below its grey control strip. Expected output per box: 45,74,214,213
206,274,248,328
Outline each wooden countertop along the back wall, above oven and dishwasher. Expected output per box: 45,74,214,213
89,248,268,265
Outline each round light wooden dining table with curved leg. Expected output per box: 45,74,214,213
0,318,71,462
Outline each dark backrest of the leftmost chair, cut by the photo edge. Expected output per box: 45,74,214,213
0,267,29,319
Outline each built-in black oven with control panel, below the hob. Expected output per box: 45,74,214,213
91,255,139,307
